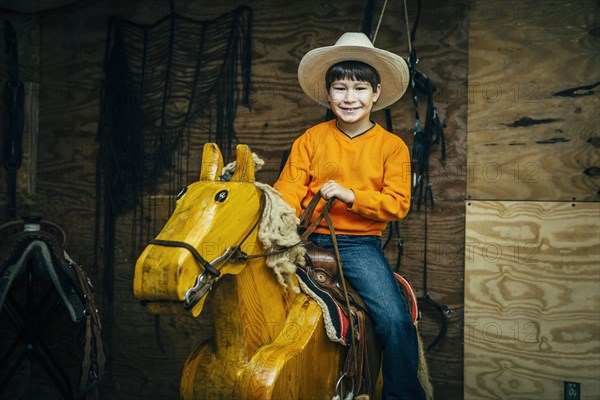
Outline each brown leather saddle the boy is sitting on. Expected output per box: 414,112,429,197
296,193,418,399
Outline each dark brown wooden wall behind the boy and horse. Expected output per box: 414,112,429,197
0,0,469,400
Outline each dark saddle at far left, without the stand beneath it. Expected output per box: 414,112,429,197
0,217,105,394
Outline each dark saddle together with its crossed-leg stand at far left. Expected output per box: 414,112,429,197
0,217,105,399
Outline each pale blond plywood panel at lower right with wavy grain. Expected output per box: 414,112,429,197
464,201,600,400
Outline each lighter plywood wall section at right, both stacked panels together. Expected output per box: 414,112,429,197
464,0,600,400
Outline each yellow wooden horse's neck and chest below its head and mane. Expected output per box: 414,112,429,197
211,234,296,355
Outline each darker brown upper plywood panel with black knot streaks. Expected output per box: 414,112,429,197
467,0,600,201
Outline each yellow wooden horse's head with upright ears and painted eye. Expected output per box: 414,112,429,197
134,143,262,316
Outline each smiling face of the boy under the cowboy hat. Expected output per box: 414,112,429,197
327,78,381,126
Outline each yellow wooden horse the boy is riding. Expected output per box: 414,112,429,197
134,143,432,400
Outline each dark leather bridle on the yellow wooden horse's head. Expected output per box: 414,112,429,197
148,190,264,310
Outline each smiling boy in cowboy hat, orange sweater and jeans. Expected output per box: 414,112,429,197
274,32,425,400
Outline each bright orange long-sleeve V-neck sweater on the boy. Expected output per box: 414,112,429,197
274,119,411,236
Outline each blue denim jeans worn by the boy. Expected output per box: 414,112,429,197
310,234,425,400
